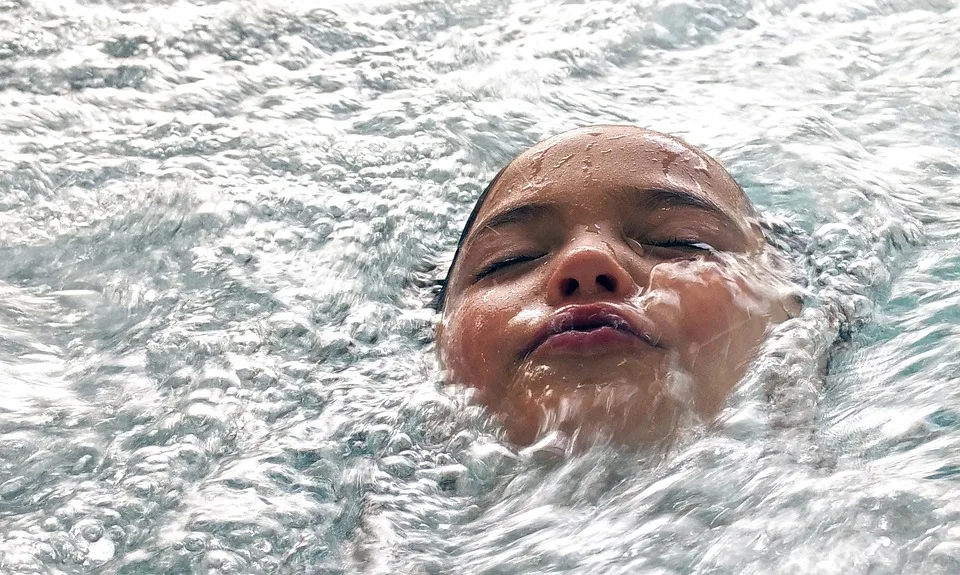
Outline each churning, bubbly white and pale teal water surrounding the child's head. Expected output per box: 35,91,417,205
0,0,960,574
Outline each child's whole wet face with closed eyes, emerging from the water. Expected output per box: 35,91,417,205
438,126,786,445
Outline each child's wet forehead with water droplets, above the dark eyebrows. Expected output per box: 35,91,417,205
478,126,753,223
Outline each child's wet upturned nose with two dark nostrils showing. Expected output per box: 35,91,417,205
547,241,639,305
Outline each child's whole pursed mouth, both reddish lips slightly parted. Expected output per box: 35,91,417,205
523,304,660,358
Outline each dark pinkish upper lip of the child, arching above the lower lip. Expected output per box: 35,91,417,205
523,303,662,357
